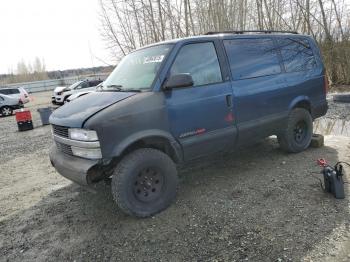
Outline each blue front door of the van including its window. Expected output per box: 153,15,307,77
165,42,237,160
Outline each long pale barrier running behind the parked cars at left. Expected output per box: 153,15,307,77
1,74,108,93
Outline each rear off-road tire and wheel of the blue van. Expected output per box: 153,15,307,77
277,108,313,153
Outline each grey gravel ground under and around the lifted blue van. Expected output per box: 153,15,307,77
0,93,350,261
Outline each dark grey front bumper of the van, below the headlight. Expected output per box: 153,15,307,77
50,145,99,186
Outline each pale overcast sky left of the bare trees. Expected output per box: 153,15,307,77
0,0,110,73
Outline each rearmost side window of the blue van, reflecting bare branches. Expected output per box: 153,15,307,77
278,38,316,72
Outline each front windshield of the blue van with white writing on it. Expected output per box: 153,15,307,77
100,44,172,91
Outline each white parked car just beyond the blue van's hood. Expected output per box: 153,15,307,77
51,80,102,105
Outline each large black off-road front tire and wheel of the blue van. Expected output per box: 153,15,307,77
112,148,178,217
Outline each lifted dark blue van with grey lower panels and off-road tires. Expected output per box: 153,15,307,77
50,31,328,217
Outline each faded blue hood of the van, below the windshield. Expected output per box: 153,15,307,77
50,92,137,128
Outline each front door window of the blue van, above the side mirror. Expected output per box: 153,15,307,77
170,42,222,86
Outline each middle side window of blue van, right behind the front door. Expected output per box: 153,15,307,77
224,38,281,80
